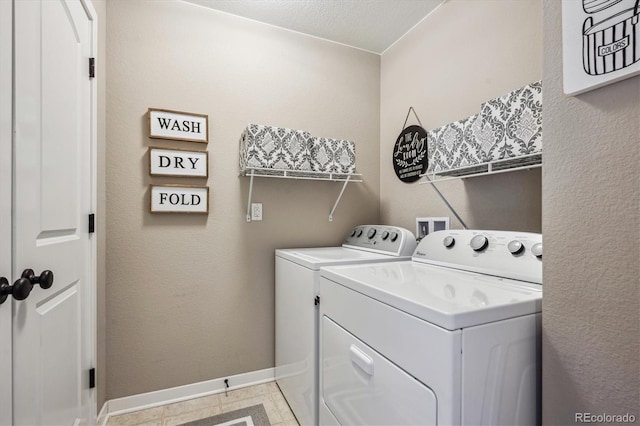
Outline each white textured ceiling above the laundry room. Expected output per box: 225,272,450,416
184,0,443,53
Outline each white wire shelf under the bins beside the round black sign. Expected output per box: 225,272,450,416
420,153,542,185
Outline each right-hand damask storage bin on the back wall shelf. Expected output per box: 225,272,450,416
311,137,356,174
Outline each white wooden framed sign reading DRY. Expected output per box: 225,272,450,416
149,146,209,178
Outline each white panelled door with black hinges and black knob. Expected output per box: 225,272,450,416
0,0,96,425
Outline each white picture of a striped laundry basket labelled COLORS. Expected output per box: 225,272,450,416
562,0,640,95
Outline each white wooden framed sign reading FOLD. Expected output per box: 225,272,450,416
149,185,209,214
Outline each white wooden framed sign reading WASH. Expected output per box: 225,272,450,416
148,108,209,143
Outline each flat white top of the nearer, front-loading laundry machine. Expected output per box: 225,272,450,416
320,262,542,330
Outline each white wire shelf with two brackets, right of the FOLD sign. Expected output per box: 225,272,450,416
240,168,362,222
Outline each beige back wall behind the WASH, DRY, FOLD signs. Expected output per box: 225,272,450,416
106,1,380,399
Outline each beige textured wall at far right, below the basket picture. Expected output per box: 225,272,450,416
542,0,640,425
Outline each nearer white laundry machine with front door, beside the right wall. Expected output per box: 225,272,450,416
319,230,542,425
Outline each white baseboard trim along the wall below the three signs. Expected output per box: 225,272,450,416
96,368,275,426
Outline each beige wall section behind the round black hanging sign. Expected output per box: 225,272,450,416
380,0,547,232
